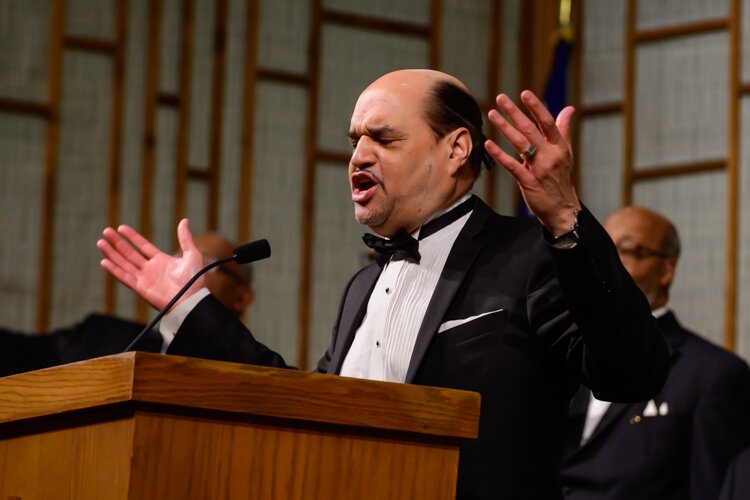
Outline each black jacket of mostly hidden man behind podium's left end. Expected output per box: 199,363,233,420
0,314,162,376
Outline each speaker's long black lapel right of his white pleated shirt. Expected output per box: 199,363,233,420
405,198,492,383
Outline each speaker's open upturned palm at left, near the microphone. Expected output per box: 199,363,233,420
96,219,209,309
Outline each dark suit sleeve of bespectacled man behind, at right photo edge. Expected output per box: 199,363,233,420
690,357,750,499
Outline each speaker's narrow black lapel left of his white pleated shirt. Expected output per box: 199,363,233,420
328,264,381,374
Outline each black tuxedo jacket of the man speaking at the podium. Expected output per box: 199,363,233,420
168,199,668,500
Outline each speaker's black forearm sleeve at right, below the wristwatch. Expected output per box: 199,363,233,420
549,209,669,402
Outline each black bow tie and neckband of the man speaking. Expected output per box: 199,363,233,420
362,196,474,267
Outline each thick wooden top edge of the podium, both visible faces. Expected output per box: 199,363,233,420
0,352,480,439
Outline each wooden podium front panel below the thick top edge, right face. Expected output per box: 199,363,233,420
131,413,458,500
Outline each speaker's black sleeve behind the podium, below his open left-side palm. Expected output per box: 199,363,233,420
167,295,293,368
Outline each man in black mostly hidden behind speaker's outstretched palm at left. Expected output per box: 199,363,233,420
0,234,254,376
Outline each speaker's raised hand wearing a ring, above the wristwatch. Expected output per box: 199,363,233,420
485,90,581,236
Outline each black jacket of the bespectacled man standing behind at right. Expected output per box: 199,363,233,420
562,313,750,500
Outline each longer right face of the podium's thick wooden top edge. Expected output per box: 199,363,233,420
133,353,479,438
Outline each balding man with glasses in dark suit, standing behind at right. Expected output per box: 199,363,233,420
562,207,750,500
